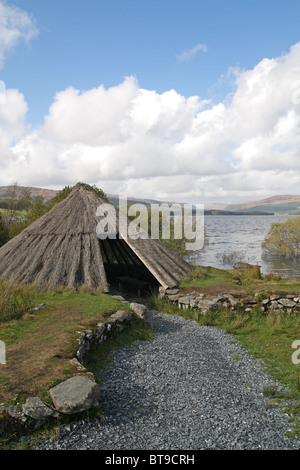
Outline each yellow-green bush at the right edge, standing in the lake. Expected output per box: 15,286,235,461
262,217,300,257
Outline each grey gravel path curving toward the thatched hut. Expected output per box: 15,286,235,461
39,311,300,451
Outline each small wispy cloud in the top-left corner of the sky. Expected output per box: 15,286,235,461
0,1,39,68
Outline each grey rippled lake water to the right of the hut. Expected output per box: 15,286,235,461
188,215,300,278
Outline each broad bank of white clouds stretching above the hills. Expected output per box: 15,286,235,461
0,43,300,203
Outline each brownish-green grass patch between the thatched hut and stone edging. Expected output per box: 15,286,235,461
0,289,130,403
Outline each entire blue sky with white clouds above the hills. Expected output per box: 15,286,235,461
0,0,300,204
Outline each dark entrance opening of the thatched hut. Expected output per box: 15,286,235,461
99,238,159,297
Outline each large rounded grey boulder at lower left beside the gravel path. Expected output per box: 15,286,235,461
49,375,100,414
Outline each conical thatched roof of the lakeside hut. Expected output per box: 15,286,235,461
0,183,191,292
